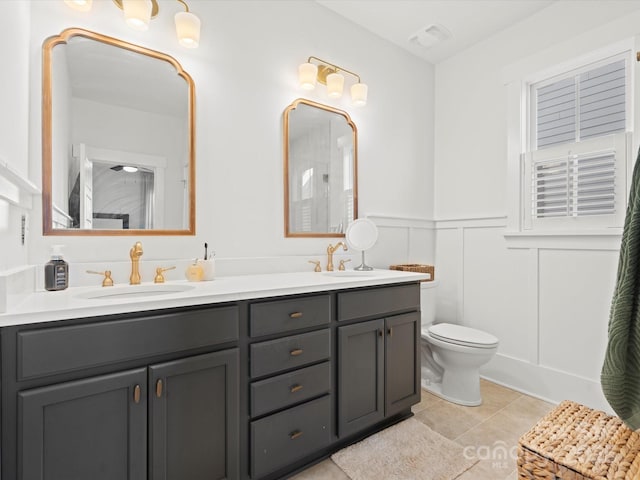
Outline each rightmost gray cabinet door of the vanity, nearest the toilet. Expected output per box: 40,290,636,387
385,312,420,416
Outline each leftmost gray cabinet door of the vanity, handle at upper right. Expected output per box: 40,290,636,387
18,368,147,480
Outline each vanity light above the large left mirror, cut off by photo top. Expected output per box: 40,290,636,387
64,0,200,48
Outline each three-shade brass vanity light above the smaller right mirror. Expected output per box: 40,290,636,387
298,56,368,107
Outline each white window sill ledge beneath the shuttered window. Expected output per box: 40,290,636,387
504,228,622,250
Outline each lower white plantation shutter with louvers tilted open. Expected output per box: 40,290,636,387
525,133,630,228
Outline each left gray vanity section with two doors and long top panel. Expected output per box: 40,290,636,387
2,305,240,480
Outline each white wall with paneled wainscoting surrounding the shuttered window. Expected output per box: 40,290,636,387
434,1,640,409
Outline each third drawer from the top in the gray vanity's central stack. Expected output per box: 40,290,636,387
251,362,331,417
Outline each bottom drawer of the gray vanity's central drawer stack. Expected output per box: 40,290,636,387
251,395,331,478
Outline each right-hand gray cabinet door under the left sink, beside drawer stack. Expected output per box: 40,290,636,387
149,348,239,480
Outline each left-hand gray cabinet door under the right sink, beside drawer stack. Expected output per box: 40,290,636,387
338,319,384,437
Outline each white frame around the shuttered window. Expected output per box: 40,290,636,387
503,37,640,248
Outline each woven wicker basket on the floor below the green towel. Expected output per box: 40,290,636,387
518,400,640,480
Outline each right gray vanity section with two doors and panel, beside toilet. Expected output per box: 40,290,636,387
338,285,420,438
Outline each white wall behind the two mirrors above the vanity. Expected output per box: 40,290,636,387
16,0,434,269
